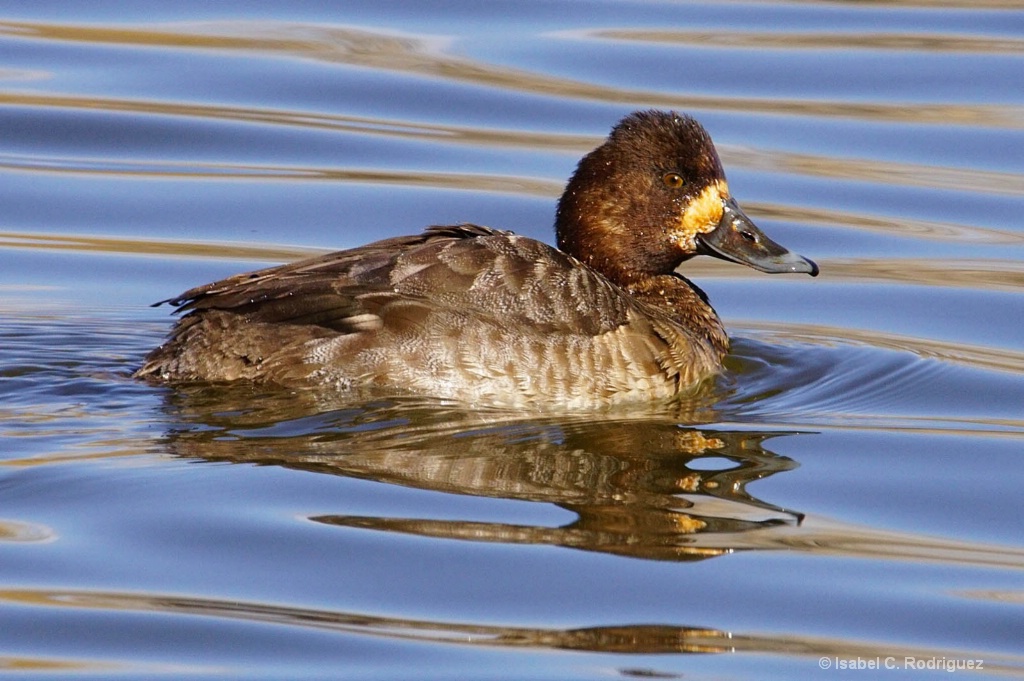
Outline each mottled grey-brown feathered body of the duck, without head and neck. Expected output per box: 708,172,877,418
138,225,721,408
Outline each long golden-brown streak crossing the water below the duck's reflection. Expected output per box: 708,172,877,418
0,589,1024,677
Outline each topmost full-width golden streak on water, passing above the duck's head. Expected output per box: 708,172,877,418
0,20,1024,129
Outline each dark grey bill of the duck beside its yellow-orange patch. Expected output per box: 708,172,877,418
697,199,818,276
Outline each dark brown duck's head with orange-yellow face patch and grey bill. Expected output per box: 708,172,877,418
555,111,818,285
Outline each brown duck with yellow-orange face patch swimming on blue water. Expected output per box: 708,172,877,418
134,111,818,410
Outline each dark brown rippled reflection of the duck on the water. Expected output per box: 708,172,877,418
155,388,802,560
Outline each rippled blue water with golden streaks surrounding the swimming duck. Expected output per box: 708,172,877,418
0,0,1024,680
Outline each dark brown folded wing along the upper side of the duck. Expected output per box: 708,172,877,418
158,224,631,334
